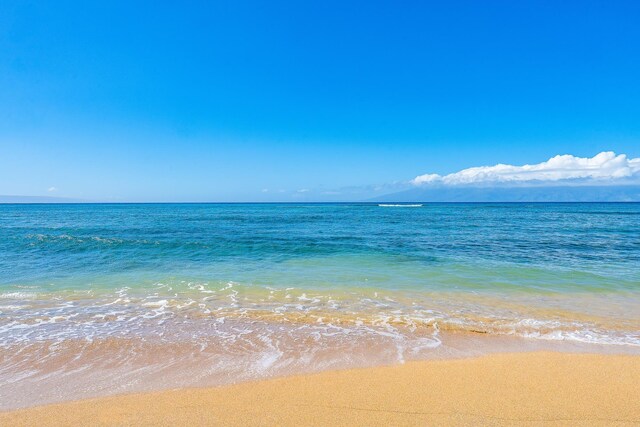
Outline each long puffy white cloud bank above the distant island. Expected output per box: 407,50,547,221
411,151,640,185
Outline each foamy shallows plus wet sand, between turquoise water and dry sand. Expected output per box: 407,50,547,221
0,281,640,409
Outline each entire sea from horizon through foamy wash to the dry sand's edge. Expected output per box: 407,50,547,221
0,203,640,406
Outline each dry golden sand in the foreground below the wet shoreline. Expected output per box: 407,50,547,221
0,353,640,426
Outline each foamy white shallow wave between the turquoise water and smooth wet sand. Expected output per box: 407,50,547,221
0,282,640,349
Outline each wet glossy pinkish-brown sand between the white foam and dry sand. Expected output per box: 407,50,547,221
0,332,640,413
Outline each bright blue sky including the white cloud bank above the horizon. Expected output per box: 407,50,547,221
0,0,640,202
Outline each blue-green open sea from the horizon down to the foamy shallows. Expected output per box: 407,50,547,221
0,203,640,290
